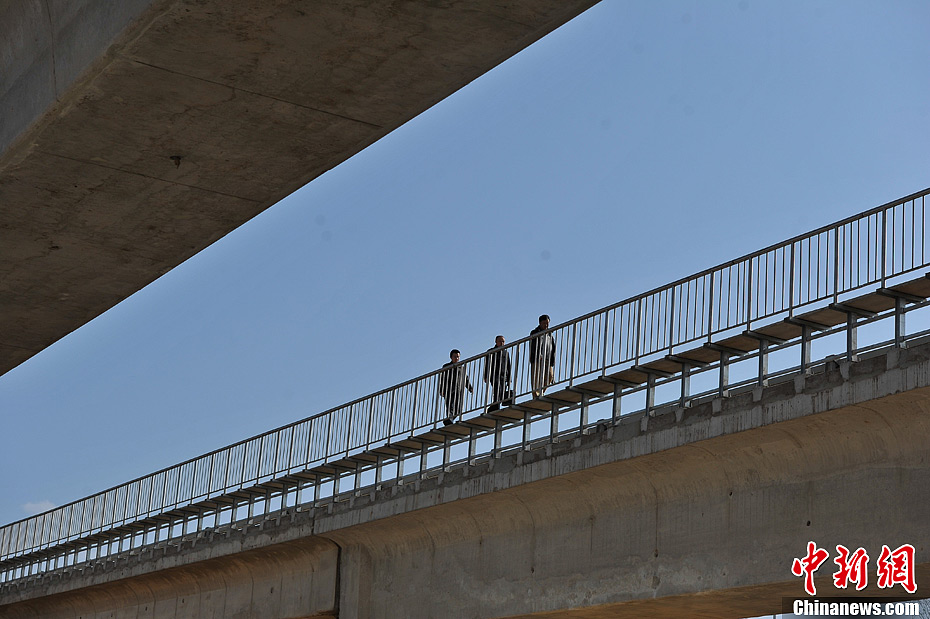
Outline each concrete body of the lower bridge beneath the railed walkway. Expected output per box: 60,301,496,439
0,344,930,618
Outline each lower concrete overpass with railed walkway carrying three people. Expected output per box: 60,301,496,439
0,189,930,617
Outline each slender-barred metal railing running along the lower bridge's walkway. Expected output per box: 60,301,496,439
0,189,930,583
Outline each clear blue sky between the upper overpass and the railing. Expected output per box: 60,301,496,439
0,0,930,523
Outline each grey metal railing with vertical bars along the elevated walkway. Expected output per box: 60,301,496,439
0,188,930,560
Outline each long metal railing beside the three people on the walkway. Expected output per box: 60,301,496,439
0,189,930,572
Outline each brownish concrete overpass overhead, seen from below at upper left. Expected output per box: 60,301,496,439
0,0,594,373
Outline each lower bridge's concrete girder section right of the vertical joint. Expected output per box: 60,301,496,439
327,410,930,618
